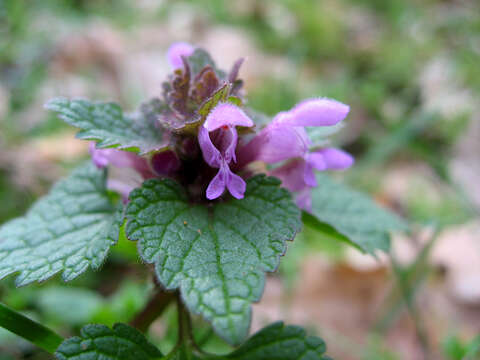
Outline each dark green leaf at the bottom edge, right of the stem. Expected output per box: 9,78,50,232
225,322,329,360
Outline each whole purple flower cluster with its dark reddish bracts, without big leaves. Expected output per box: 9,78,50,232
91,43,353,210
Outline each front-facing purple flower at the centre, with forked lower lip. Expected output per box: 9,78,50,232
198,103,254,200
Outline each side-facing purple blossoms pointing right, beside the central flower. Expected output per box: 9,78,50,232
239,98,354,210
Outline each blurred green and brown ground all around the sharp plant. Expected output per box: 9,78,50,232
0,0,480,360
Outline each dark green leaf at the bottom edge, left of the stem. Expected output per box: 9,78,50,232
55,324,162,360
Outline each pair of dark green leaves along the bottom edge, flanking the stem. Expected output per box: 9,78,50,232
55,322,330,360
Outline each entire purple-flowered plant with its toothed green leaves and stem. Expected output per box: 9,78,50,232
0,43,404,360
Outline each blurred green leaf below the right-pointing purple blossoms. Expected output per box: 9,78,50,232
312,174,407,254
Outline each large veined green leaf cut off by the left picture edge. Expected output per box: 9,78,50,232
0,163,122,286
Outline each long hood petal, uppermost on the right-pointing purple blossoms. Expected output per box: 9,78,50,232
284,98,350,126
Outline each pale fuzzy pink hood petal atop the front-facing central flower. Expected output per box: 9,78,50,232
203,103,254,131
